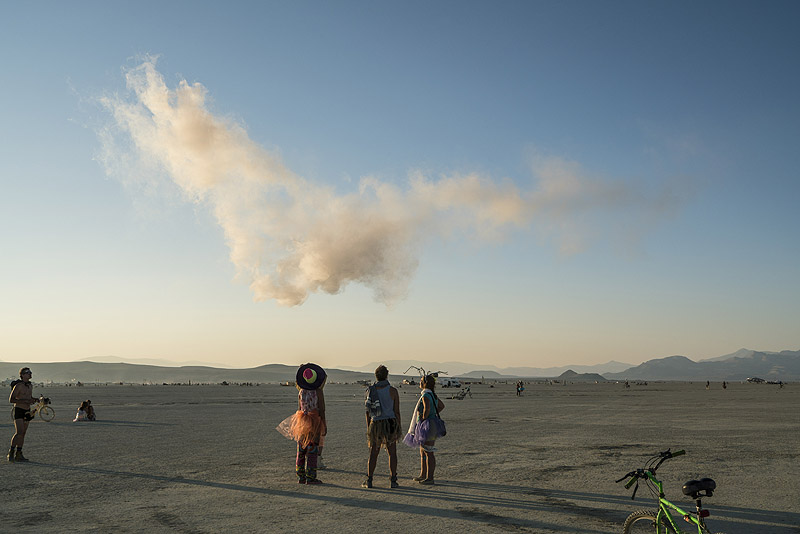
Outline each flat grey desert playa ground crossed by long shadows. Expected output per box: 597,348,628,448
0,382,800,534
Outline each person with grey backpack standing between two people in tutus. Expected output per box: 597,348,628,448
361,365,400,488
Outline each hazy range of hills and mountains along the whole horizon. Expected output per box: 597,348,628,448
0,349,800,384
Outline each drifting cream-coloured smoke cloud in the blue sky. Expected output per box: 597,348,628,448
94,57,680,306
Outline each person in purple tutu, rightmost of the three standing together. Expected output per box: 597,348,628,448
403,375,446,484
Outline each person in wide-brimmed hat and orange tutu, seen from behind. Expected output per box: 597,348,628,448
278,363,328,484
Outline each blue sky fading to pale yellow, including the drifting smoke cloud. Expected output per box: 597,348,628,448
0,0,800,367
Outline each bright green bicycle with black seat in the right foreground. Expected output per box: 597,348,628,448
617,449,717,534
